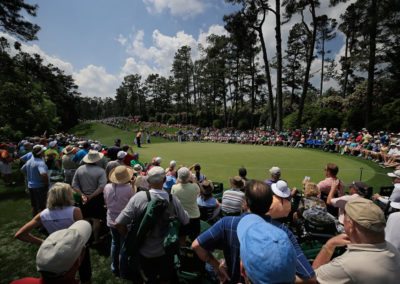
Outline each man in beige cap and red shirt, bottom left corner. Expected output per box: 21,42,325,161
11,220,92,284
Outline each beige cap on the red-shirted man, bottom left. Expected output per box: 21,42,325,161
36,220,92,276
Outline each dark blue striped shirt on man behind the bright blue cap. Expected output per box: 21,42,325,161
197,213,315,283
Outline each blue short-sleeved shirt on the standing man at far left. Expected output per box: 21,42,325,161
21,157,48,188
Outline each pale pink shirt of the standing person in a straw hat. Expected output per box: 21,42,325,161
103,183,134,227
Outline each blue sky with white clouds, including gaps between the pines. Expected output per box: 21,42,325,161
4,0,347,98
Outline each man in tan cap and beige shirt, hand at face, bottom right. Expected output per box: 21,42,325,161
313,197,400,284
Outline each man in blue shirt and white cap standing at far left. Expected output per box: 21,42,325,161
21,145,49,216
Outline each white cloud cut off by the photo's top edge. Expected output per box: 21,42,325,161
143,0,206,18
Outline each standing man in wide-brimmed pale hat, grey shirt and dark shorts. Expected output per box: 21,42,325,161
72,150,107,244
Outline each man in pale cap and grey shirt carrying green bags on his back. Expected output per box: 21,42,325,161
115,166,189,283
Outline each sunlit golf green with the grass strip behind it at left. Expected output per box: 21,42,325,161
73,123,391,192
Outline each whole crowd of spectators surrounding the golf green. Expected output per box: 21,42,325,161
3,129,400,283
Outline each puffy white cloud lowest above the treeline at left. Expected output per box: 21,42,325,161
73,65,120,98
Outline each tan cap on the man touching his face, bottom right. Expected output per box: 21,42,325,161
345,198,386,232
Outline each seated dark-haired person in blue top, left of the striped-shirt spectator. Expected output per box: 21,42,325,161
197,180,221,222
